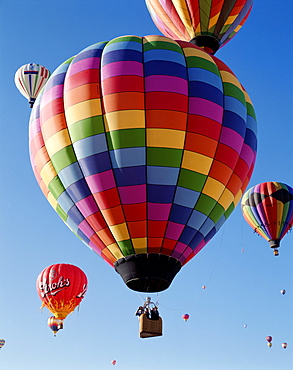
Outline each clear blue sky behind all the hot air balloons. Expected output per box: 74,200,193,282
0,0,293,370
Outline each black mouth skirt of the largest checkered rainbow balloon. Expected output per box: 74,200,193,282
114,253,182,293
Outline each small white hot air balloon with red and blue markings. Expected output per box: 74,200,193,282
14,63,50,108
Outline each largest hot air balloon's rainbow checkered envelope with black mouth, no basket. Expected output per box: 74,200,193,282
30,36,256,292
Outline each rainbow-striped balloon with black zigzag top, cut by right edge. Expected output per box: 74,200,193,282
241,182,293,256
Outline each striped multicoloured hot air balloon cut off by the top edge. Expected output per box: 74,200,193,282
146,0,253,54
